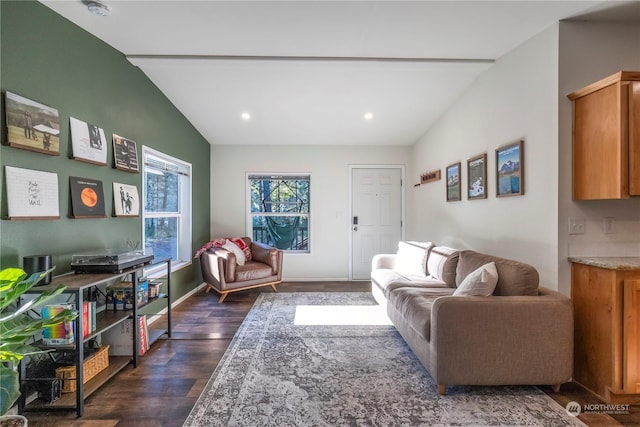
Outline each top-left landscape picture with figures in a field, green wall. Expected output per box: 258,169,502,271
5,92,60,156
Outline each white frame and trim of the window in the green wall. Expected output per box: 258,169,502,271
141,145,193,275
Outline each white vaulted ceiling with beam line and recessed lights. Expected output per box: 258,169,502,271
41,0,640,145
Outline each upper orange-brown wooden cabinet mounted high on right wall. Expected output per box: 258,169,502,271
568,71,640,200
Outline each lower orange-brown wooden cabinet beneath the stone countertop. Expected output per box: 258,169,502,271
571,260,640,403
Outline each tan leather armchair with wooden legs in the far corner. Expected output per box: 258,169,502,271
200,237,283,303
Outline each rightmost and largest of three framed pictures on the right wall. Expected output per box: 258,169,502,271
496,140,524,197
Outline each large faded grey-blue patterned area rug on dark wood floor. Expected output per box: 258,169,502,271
184,292,584,427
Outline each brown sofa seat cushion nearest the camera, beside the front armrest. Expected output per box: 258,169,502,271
388,287,454,341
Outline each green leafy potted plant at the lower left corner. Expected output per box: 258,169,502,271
0,268,78,425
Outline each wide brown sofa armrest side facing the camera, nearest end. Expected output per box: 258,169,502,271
430,288,573,385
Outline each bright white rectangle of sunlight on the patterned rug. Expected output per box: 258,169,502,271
293,305,391,326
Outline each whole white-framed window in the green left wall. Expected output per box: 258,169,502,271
142,146,191,265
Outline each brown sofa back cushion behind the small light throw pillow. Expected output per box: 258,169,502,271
456,250,539,296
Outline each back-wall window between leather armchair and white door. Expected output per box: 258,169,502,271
247,174,311,253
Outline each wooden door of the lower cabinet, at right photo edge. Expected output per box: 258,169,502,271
622,280,640,393
